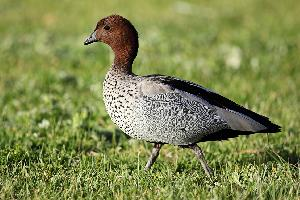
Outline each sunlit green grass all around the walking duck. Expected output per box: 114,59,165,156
0,0,300,199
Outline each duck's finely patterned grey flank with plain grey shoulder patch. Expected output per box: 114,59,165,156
136,80,229,145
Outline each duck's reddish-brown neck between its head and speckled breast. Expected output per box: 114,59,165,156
111,41,138,74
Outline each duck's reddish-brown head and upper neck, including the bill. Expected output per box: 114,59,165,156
84,15,139,68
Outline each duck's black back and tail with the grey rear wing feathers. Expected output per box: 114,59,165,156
145,75,281,141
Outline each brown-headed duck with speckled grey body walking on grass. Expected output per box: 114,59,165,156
84,14,281,178
